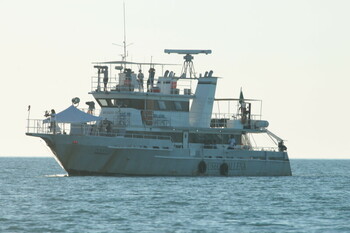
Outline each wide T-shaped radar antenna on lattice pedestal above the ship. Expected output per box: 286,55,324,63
164,49,211,78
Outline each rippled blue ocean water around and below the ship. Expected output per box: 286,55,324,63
0,158,350,233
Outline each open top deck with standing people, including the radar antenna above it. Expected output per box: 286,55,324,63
90,49,216,99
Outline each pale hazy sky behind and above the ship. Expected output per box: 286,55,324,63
0,0,350,159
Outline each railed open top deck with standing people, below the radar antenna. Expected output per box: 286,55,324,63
90,65,213,99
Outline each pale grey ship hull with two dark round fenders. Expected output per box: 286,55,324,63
31,134,291,176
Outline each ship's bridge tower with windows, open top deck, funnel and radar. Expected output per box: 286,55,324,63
90,49,217,127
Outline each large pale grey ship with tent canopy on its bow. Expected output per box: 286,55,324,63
26,49,292,177
